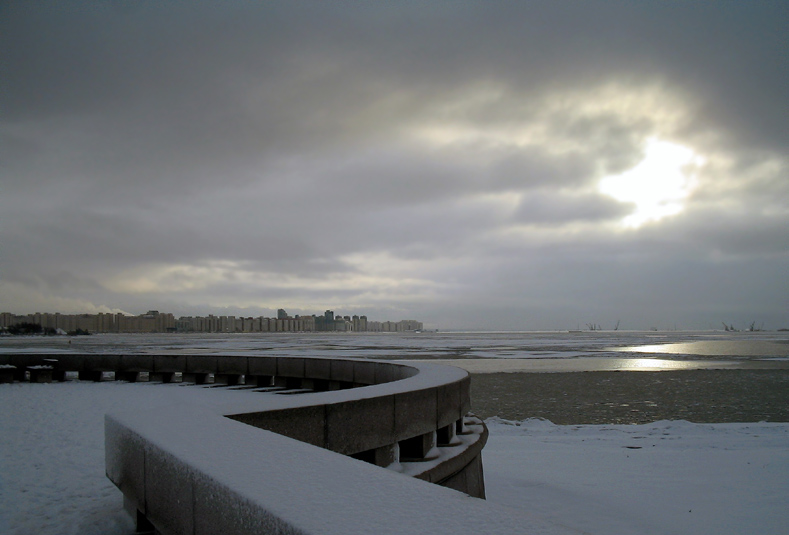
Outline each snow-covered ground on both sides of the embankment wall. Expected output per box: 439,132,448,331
0,381,789,535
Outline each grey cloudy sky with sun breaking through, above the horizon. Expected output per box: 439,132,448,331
0,0,789,330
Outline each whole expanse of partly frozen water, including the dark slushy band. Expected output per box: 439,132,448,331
0,331,789,424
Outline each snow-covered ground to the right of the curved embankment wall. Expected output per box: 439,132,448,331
483,419,789,535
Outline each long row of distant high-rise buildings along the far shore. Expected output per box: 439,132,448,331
0,309,422,333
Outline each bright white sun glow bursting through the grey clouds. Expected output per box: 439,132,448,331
599,139,704,228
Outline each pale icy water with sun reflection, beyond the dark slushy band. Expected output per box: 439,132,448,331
0,331,789,373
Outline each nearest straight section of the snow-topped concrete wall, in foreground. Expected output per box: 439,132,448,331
106,406,568,535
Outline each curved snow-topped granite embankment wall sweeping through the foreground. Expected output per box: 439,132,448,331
6,354,553,534
